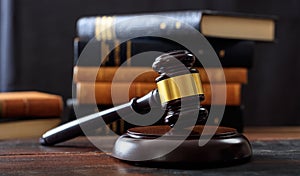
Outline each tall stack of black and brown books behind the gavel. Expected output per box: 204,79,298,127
73,11,275,133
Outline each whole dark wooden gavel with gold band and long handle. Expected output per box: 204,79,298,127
40,50,208,146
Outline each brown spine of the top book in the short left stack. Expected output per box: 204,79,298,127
0,98,63,118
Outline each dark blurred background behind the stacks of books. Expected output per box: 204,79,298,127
0,0,300,125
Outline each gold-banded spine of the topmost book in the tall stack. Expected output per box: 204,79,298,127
77,11,202,40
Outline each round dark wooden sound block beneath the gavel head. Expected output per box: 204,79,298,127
112,125,252,167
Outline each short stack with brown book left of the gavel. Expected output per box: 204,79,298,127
0,91,63,140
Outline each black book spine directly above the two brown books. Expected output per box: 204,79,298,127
74,37,254,68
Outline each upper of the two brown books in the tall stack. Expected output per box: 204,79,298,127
73,66,248,84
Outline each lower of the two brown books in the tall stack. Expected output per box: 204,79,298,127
76,82,242,106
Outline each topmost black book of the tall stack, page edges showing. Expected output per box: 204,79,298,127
77,10,276,41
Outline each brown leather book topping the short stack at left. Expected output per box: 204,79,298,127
0,92,63,118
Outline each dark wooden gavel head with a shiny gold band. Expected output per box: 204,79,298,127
152,50,208,127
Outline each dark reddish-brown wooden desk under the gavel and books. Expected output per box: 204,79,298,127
0,127,300,176
